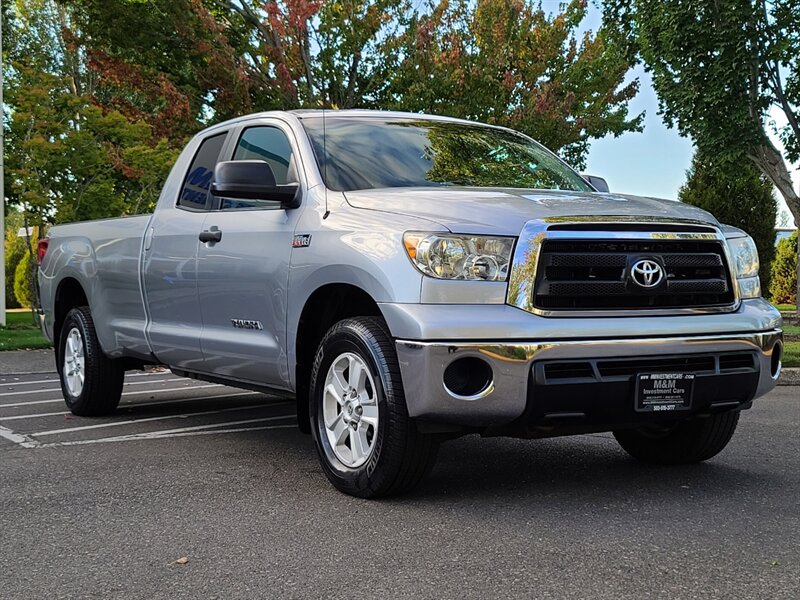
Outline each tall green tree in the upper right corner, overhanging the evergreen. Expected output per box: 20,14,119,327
605,0,800,310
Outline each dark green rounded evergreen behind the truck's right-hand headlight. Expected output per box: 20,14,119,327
678,152,777,292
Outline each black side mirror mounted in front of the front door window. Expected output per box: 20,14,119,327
211,160,300,208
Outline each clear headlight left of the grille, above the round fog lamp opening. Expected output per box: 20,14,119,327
403,231,514,281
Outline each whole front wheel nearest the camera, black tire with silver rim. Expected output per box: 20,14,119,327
310,317,438,498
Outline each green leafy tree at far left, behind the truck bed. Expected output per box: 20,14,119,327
3,0,177,232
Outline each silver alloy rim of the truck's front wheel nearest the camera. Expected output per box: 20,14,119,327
322,352,378,469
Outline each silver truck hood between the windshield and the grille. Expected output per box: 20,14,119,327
345,187,719,235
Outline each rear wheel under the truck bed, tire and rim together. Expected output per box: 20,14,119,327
56,306,125,417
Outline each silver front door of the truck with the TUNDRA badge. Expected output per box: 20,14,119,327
197,119,306,388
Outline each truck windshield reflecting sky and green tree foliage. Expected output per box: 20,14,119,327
302,115,592,192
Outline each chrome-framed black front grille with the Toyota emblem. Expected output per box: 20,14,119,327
508,221,737,316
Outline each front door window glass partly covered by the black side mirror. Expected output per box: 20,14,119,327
220,127,297,210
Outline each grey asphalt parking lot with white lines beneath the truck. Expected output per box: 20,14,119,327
0,364,800,600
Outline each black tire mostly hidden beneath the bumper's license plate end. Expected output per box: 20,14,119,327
614,411,739,465
